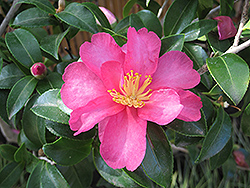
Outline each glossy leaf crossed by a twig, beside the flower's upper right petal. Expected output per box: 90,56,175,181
183,43,213,89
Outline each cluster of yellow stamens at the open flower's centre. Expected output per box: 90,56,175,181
108,70,152,108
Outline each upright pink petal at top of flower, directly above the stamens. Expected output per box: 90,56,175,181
123,27,161,75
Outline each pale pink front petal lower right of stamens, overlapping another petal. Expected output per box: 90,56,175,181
138,89,183,125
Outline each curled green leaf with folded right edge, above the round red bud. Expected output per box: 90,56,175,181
40,29,69,60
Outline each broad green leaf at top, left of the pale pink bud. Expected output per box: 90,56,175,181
55,3,98,33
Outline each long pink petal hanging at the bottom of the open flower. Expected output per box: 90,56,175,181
99,107,147,171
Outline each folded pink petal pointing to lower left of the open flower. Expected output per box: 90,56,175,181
69,96,124,136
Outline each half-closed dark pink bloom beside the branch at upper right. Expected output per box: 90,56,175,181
213,16,237,40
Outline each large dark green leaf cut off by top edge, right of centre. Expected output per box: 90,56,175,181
163,0,198,36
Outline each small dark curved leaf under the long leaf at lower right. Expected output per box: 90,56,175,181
209,138,233,170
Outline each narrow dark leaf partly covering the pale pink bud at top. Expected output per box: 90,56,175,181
83,2,111,29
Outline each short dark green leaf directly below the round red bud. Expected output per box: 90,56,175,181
36,72,64,94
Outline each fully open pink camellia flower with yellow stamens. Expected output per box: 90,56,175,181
61,27,202,171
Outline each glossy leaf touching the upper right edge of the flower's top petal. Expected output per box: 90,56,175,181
136,10,162,38
